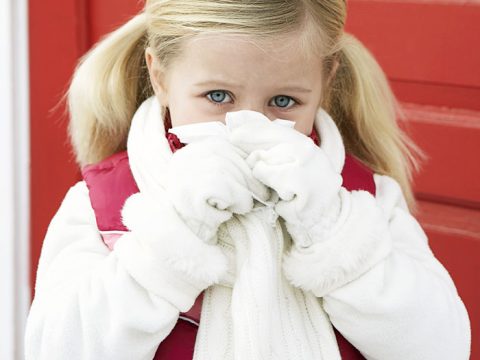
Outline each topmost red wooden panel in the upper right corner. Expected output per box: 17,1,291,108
346,0,480,109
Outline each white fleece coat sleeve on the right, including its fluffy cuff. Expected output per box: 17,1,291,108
286,174,471,360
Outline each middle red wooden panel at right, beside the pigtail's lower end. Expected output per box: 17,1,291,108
403,104,480,208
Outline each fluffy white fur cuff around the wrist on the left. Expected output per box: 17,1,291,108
114,193,228,311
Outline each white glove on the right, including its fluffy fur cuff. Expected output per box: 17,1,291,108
225,114,392,297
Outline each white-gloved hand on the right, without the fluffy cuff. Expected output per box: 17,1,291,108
229,116,342,247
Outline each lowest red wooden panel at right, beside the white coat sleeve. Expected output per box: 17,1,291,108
417,201,480,360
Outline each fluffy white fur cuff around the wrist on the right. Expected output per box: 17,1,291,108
283,188,392,297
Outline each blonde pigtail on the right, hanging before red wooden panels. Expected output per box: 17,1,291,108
323,34,425,213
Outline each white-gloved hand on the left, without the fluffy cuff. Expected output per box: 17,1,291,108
166,137,269,243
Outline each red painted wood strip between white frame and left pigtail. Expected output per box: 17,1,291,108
29,0,85,291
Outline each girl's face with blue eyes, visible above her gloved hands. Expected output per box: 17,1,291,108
146,34,322,135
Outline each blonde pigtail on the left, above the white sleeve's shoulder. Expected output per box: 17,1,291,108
67,12,153,165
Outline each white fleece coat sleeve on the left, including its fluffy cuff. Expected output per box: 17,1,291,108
25,182,228,360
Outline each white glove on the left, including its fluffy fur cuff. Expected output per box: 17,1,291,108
115,137,269,311
